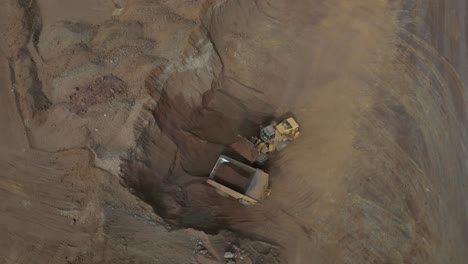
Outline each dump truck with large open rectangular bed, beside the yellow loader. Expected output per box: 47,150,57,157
207,155,270,206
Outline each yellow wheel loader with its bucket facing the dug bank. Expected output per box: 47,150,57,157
231,117,300,165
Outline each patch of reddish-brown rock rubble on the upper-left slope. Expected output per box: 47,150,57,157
70,75,126,114
